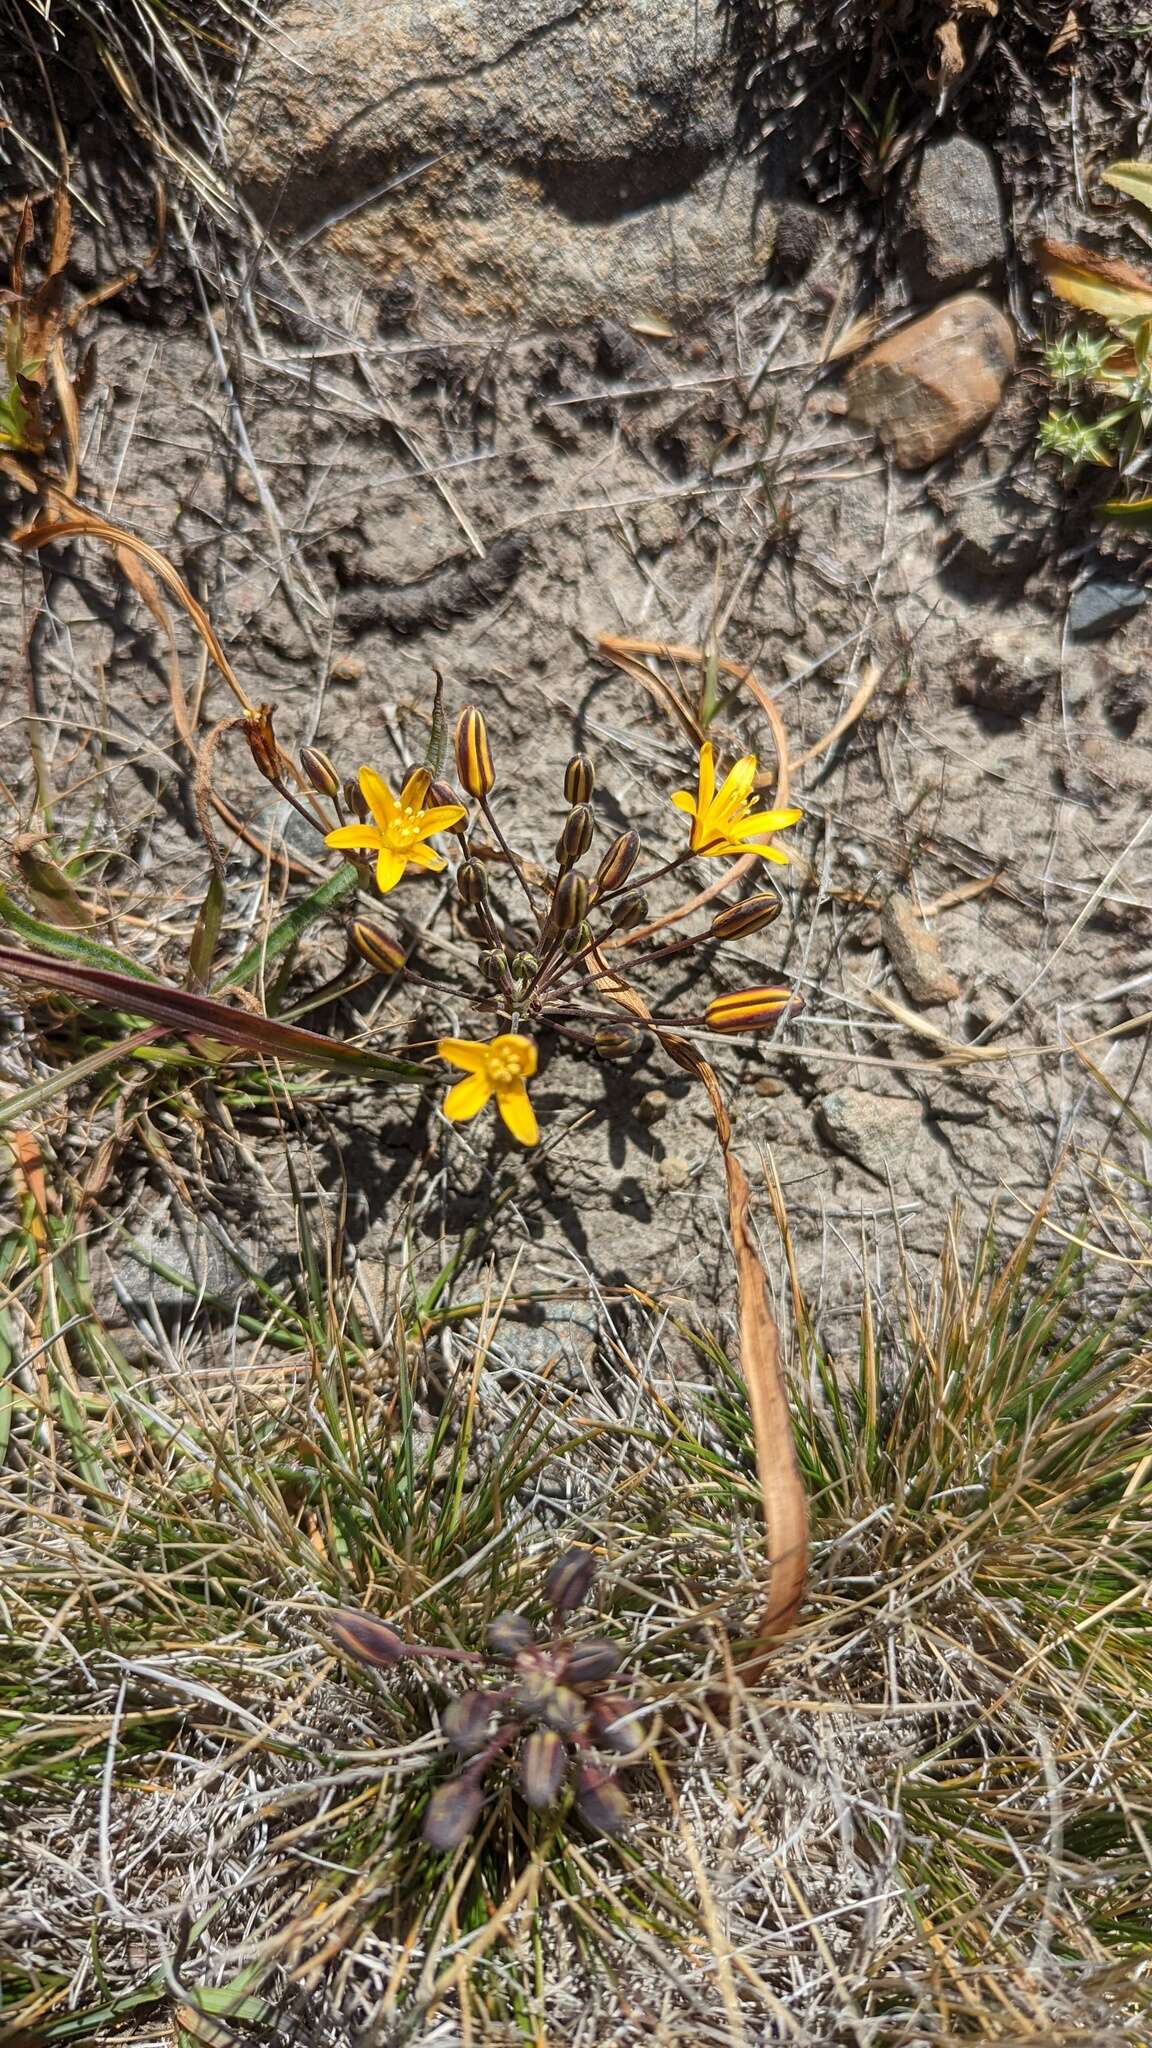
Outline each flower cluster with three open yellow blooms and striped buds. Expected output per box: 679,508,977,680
248,705,801,1145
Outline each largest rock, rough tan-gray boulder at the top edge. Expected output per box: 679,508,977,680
230,0,773,326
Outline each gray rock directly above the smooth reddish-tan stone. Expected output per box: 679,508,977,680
900,135,1004,293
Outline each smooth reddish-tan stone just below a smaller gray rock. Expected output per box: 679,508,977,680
845,291,1017,469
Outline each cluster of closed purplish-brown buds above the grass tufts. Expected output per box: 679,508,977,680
330,1548,644,1849
